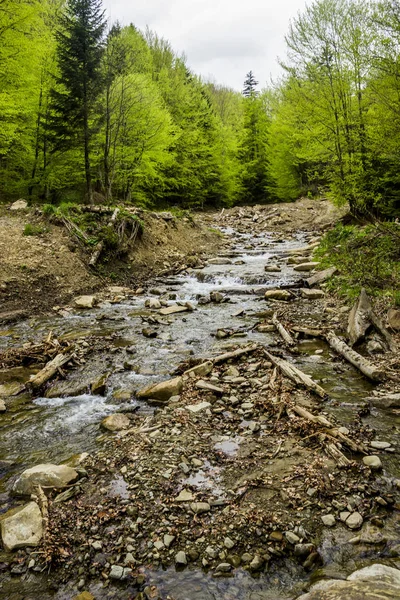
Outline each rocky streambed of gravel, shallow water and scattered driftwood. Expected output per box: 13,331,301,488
0,200,400,600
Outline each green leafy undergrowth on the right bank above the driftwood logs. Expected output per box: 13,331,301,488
314,223,400,303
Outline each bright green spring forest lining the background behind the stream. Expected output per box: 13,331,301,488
0,0,400,217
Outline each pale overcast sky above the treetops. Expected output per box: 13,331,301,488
103,0,306,90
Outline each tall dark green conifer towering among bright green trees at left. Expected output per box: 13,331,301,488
50,0,106,202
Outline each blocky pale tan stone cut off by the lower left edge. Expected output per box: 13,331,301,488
0,502,43,552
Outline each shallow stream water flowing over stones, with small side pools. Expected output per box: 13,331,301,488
0,229,400,600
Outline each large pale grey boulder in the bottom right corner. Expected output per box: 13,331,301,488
298,564,400,600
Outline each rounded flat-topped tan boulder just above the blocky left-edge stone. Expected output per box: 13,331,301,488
13,464,78,496
